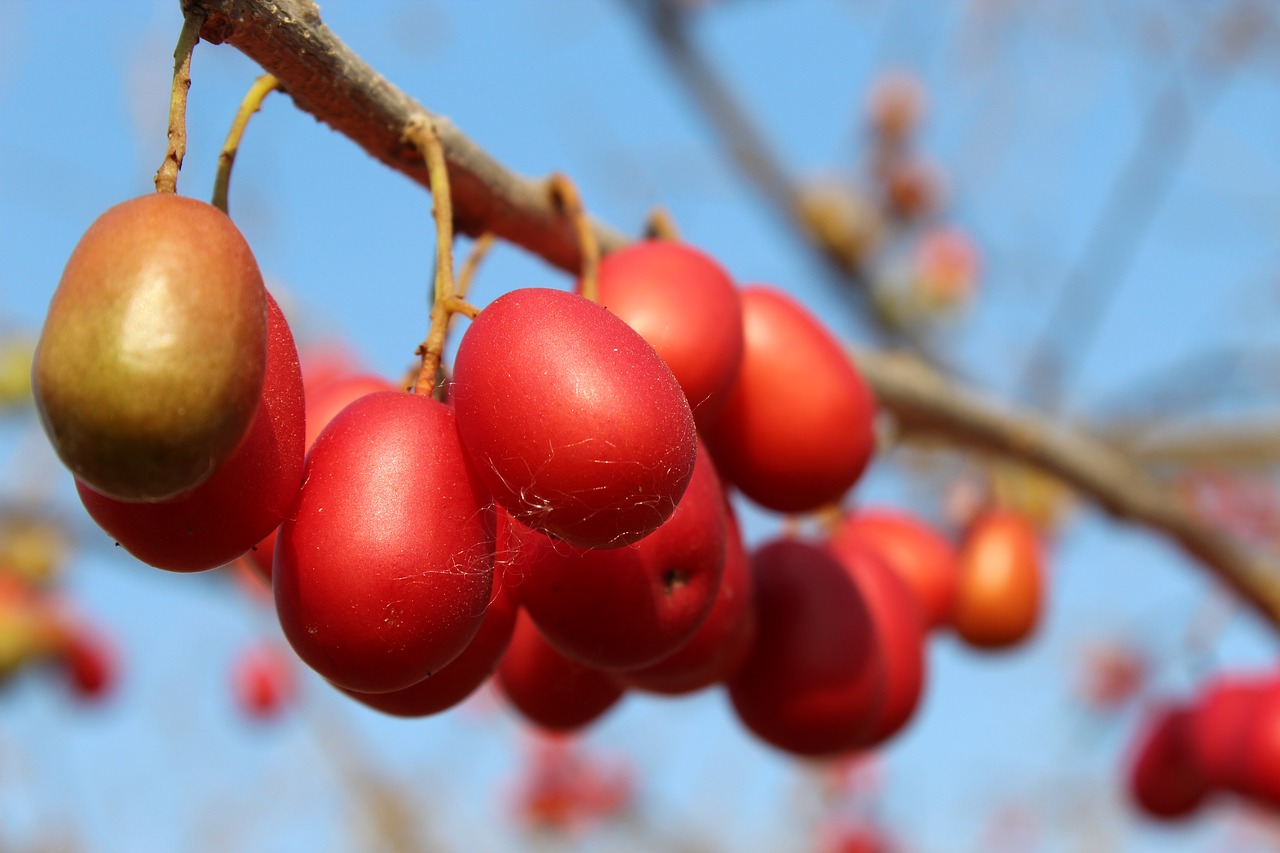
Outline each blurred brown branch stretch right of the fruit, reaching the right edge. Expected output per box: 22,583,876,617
855,350,1280,626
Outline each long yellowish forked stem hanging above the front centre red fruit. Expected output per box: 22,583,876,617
404,117,477,394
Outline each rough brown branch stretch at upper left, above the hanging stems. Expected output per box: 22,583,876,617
180,0,626,273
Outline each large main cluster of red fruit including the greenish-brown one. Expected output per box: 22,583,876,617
32,184,1039,754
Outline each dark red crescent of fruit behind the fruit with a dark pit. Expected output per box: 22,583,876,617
618,503,755,695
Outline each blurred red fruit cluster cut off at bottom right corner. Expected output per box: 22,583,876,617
1129,674,1280,821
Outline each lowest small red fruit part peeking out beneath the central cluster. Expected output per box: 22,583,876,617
494,608,623,733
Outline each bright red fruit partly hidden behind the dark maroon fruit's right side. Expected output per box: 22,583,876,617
827,540,925,747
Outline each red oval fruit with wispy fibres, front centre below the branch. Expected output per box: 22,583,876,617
451,288,696,548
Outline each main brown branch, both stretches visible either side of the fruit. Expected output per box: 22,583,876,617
183,0,1280,626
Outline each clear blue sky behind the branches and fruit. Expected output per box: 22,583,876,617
0,0,1280,853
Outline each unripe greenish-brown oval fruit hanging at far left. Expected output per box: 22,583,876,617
32,193,266,501
